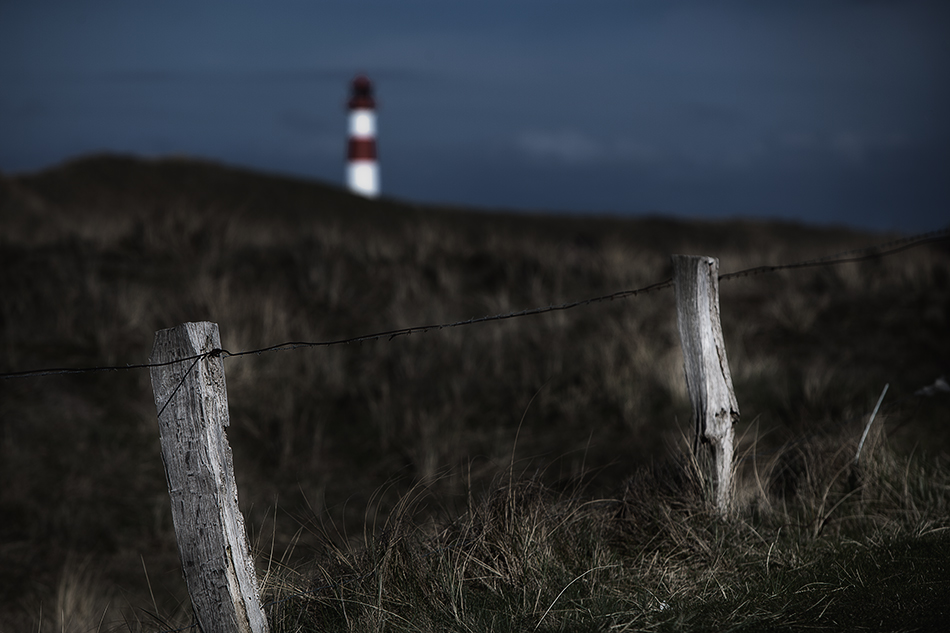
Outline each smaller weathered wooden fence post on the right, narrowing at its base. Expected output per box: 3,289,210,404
673,255,739,513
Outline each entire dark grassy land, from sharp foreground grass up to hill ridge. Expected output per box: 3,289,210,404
0,156,950,631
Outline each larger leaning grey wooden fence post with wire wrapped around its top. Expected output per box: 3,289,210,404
149,322,268,633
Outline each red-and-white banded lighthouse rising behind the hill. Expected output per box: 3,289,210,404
346,75,379,198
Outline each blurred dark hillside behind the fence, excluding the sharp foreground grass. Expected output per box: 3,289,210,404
0,156,950,630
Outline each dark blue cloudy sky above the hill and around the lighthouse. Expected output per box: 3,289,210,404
0,0,950,232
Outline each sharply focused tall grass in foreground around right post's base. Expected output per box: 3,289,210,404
265,434,950,632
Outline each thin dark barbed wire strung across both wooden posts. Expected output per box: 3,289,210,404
0,228,950,379
